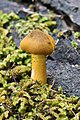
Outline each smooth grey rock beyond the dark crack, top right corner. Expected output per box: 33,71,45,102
41,0,80,31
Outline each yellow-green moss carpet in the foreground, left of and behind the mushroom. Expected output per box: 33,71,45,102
0,12,80,120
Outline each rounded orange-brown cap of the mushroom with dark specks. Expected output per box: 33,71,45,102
20,29,55,55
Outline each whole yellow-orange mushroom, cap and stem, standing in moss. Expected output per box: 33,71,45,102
20,29,55,84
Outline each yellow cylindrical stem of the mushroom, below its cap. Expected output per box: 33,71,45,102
31,54,47,84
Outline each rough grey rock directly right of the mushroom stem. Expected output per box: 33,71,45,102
47,34,80,96
